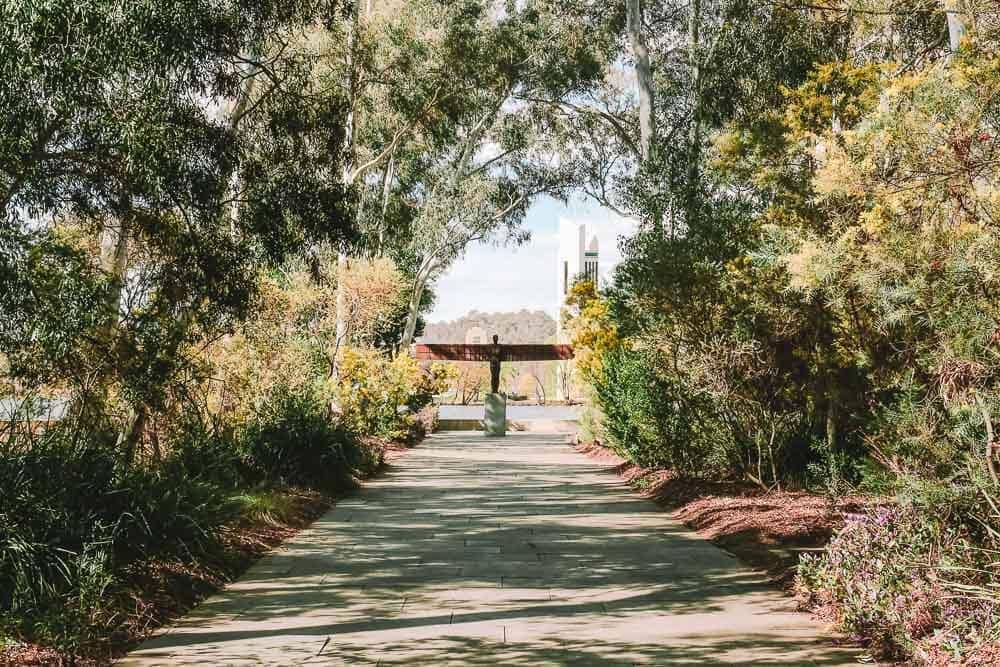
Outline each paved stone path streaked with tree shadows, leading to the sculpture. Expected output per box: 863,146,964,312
124,433,855,666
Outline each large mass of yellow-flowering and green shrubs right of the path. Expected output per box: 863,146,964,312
598,10,1000,489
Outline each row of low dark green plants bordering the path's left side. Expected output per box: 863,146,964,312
0,390,381,654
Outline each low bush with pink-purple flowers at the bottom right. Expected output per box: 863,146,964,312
796,506,1000,658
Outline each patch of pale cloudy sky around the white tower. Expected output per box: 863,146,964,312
427,197,634,322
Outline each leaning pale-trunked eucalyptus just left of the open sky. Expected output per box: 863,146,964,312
385,2,604,346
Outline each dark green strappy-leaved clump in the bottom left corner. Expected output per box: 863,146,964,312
0,427,237,651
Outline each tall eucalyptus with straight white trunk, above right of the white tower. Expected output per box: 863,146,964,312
552,0,840,227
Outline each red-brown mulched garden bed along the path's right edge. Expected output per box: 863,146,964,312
577,443,1000,667
